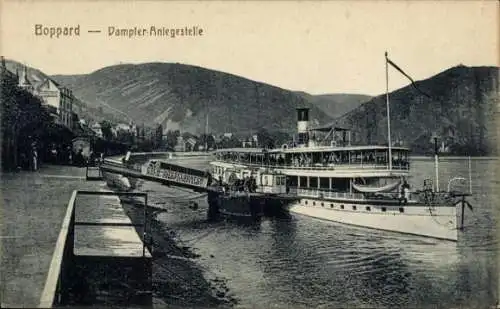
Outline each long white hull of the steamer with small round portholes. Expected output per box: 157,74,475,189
289,198,459,241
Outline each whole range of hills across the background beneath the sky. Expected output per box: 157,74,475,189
6,58,500,155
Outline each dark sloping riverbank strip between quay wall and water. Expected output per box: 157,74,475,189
122,194,237,308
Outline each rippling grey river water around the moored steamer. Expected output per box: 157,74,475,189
132,158,499,308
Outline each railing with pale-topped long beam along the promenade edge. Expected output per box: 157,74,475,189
38,190,148,308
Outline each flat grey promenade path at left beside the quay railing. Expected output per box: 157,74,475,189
0,166,104,308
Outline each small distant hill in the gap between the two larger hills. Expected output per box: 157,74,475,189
297,92,372,118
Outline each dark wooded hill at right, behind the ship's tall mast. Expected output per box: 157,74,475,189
338,65,500,155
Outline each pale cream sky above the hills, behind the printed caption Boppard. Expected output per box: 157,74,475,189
0,0,500,95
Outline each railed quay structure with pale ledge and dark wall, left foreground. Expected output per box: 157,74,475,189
38,190,152,308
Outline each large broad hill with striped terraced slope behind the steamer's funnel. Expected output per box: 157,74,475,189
53,63,331,134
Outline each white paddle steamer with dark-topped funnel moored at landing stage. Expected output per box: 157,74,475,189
211,53,470,241
